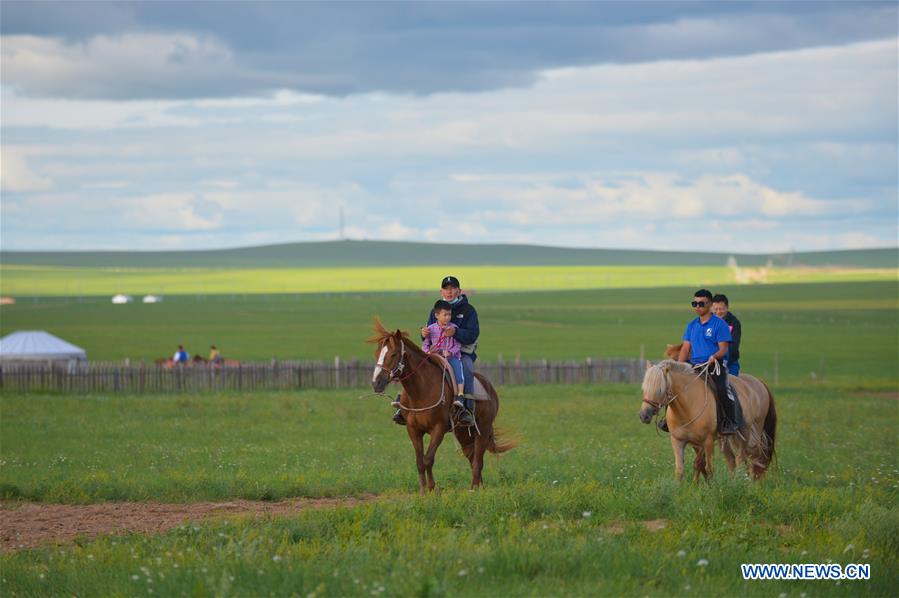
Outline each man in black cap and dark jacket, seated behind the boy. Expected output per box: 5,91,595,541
393,276,481,426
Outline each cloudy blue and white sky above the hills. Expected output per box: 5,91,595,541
0,0,899,253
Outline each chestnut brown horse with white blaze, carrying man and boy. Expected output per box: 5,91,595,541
369,319,515,493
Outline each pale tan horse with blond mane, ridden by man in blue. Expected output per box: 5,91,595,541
640,359,777,482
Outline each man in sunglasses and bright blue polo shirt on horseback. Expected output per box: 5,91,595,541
659,289,737,435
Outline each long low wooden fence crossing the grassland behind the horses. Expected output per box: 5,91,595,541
0,358,644,394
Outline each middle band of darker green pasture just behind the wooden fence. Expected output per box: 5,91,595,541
0,282,899,387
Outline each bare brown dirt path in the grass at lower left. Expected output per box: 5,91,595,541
0,494,377,552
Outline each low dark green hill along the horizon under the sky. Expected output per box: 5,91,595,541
0,241,899,268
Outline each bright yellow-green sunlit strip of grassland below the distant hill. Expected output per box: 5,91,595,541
0,264,896,300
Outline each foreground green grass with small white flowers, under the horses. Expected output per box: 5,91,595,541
0,385,899,596
